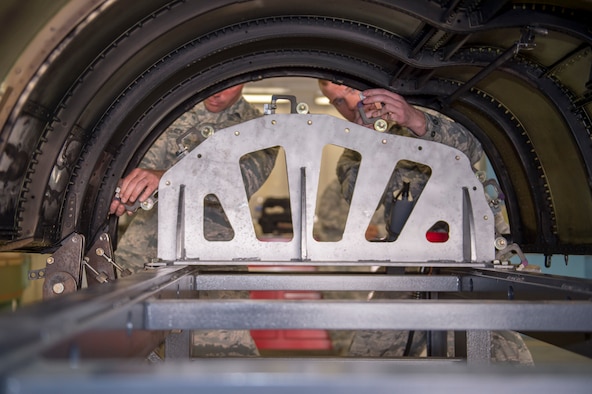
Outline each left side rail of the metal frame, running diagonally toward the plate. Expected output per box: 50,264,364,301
0,268,196,375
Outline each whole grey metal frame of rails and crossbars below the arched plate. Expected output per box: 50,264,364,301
0,267,592,393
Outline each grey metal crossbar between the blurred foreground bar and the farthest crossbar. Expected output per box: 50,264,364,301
145,300,592,332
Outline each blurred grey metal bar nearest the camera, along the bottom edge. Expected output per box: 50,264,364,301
6,358,592,394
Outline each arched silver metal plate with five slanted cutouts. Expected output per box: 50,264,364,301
158,114,494,265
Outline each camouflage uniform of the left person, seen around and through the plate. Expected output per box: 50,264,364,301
115,98,277,357
